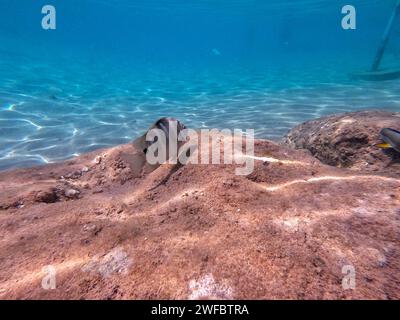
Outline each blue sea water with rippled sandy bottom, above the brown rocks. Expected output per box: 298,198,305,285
0,0,400,170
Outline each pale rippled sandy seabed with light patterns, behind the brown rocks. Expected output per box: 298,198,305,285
0,55,400,170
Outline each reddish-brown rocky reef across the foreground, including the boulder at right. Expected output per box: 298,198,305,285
0,112,400,299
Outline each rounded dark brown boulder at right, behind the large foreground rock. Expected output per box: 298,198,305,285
283,111,400,176
